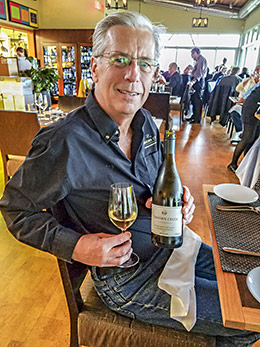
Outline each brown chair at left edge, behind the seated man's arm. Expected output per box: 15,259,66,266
0,110,40,183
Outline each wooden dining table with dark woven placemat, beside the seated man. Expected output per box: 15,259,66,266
203,184,260,332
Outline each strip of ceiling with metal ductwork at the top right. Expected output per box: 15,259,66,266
144,0,260,18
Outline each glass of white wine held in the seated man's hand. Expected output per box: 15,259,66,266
108,182,139,268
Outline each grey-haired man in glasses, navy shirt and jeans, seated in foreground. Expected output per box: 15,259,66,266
0,11,258,347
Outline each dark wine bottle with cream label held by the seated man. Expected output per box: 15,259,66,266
151,130,183,248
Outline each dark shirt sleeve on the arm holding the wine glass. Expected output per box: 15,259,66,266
0,132,82,261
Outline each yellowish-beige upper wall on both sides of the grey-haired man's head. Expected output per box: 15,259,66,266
40,0,244,33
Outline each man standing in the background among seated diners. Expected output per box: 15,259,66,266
188,47,207,123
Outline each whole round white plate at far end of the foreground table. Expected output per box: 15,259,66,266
214,183,258,204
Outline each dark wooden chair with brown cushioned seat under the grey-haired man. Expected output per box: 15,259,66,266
58,259,215,347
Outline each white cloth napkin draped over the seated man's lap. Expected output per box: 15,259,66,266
158,226,201,331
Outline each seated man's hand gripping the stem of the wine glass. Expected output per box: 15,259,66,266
72,232,133,267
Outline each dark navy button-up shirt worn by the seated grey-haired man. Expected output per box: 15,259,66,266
0,94,162,261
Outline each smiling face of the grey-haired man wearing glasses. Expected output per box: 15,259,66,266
91,25,155,120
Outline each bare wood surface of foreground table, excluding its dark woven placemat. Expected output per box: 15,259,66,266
203,184,260,332
